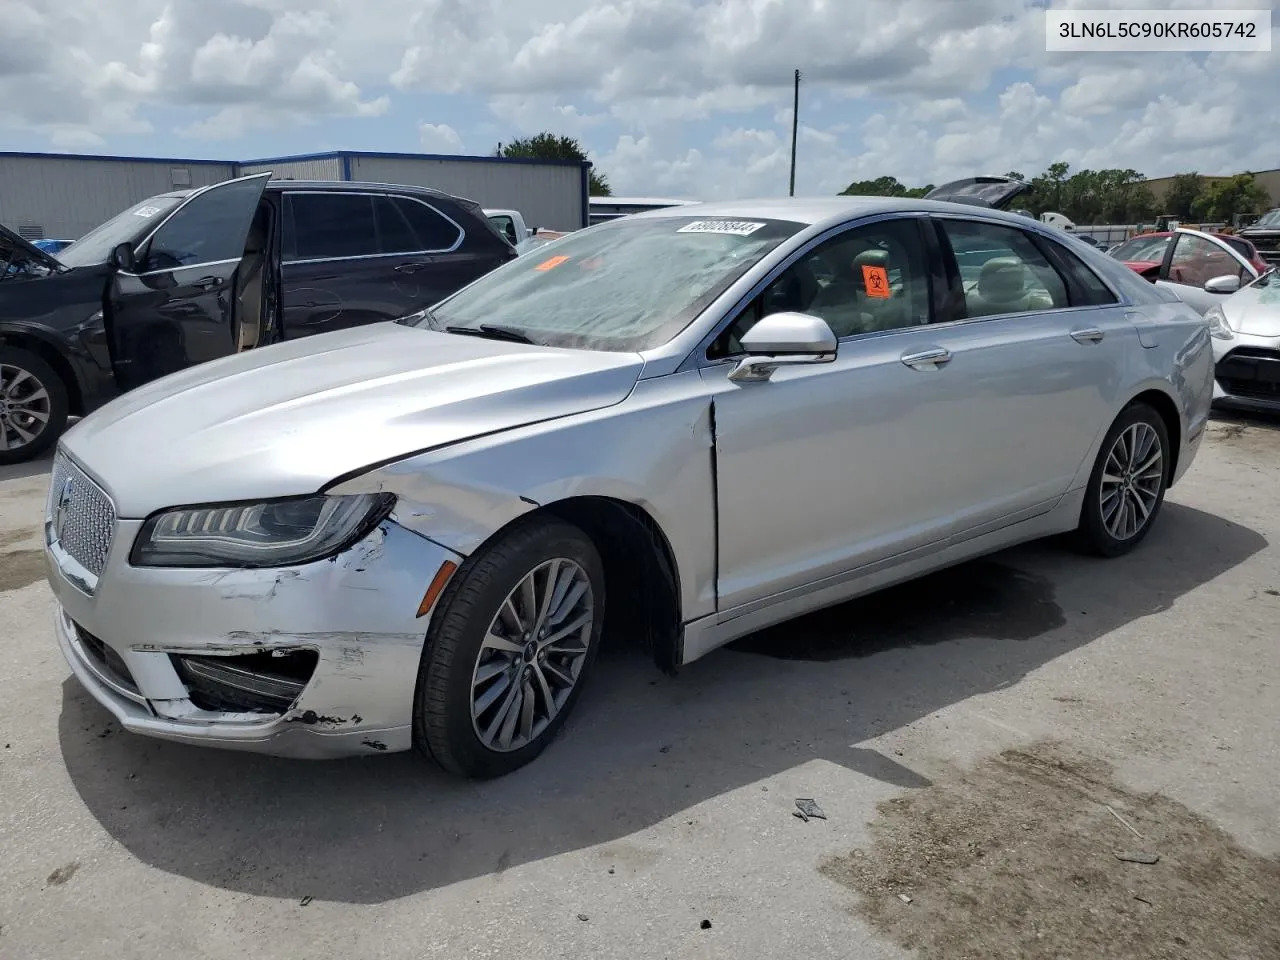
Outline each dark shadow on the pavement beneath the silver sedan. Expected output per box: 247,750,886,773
59,504,1266,904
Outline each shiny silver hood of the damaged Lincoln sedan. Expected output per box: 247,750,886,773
61,323,644,518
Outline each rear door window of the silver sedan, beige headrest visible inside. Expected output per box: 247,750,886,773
940,219,1070,317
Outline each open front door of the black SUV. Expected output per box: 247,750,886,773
106,173,271,392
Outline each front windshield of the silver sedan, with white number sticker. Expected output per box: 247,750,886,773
415,216,805,351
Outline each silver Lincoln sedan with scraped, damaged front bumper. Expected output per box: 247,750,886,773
46,197,1213,777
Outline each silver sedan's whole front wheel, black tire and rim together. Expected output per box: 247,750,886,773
413,517,604,778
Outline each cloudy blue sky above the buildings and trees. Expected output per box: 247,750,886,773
0,0,1280,200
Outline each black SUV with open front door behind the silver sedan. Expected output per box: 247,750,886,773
0,173,516,465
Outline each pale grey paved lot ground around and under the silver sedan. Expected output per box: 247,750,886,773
0,421,1280,960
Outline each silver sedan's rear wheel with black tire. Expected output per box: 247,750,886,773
1076,403,1171,557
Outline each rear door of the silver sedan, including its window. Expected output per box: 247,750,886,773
919,215,1140,539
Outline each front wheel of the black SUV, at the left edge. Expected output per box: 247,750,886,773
0,344,69,466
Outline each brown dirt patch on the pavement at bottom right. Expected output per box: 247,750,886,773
820,742,1280,960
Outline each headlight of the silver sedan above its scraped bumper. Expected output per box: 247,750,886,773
129,493,396,567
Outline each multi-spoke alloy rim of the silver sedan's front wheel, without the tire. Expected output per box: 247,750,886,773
471,558,594,753
